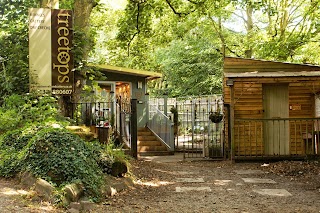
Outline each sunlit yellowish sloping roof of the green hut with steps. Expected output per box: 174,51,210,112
90,64,162,79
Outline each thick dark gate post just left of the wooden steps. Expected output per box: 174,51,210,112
131,99,138,159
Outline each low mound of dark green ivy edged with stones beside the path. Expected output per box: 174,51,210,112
0,126,107,197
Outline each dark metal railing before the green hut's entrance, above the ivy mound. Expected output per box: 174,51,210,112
71,97,137,157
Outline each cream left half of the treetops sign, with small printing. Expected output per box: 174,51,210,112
29,8,52,91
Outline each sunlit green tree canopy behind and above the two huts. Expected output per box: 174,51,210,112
101,0,320,96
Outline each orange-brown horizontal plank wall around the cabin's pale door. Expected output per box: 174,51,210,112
223,77,320,156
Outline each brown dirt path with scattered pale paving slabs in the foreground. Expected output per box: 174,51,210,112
93,155,320,213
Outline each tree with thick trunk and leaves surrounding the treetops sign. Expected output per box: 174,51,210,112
0,0,97,109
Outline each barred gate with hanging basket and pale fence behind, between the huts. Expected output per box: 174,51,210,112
149,95,225,158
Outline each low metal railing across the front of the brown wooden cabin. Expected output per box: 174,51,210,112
233,118,320,158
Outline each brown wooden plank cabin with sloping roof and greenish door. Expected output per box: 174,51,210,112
223,57,320,159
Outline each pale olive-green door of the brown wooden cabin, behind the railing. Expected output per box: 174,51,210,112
263,84,290,155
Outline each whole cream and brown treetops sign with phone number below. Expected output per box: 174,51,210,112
29,8,74,95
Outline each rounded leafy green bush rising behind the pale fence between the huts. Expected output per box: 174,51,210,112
156,36,222,97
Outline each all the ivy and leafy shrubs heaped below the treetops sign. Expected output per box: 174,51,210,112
0,95,131,201
